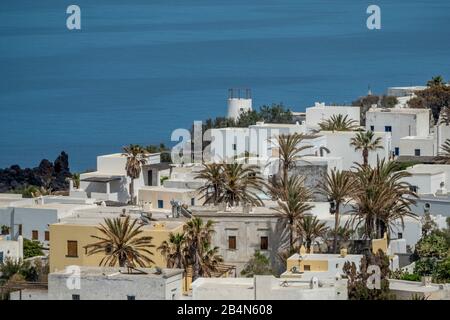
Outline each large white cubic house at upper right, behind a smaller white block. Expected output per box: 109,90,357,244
366,108,430,156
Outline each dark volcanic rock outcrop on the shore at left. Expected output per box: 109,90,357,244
0,151,71,192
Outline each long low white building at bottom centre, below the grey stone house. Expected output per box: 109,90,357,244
192,275,347,300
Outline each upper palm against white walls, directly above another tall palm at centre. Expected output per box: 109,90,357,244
275,133,312,188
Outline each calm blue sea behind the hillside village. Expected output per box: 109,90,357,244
0,0,450,171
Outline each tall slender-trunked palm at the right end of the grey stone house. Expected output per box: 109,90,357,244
270,175,313,251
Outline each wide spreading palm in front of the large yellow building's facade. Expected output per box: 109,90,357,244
85,216,154,267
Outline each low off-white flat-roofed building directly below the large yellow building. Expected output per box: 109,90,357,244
48,267,184,300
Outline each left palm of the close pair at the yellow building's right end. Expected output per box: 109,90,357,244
158,232,188,270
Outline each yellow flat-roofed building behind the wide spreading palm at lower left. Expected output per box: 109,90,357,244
49,217,184,272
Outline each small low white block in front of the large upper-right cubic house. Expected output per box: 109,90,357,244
399,135,437,157
